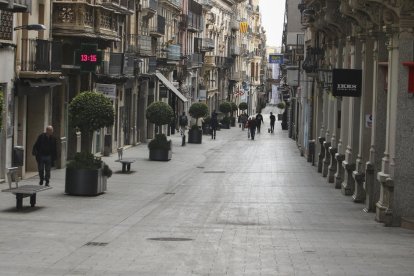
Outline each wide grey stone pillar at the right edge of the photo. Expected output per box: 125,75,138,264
390,21,414,226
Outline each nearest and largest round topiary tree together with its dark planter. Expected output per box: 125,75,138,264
65,91,114,196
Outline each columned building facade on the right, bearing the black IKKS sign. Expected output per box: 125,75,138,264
289,0,414,226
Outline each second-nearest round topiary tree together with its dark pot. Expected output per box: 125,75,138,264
146,102,174,161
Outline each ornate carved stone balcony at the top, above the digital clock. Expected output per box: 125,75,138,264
52,2,120,41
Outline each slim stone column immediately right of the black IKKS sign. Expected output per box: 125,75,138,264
352,37,374,202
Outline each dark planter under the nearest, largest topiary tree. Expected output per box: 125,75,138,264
65,168,107,196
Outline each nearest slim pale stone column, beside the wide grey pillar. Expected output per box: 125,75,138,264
375,25,400,225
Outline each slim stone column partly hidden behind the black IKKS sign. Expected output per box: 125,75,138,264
341,41,361,195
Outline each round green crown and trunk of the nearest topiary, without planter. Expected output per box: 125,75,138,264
69,91,115,152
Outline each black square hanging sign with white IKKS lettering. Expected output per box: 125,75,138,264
332,69,362,97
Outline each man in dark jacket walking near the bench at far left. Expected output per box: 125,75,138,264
32,126,56,186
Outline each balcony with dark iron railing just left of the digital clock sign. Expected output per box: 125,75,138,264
20,39,63,75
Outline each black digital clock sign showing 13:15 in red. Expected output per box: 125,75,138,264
75,44,102,72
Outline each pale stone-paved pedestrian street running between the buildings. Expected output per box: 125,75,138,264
0,115,414,275
